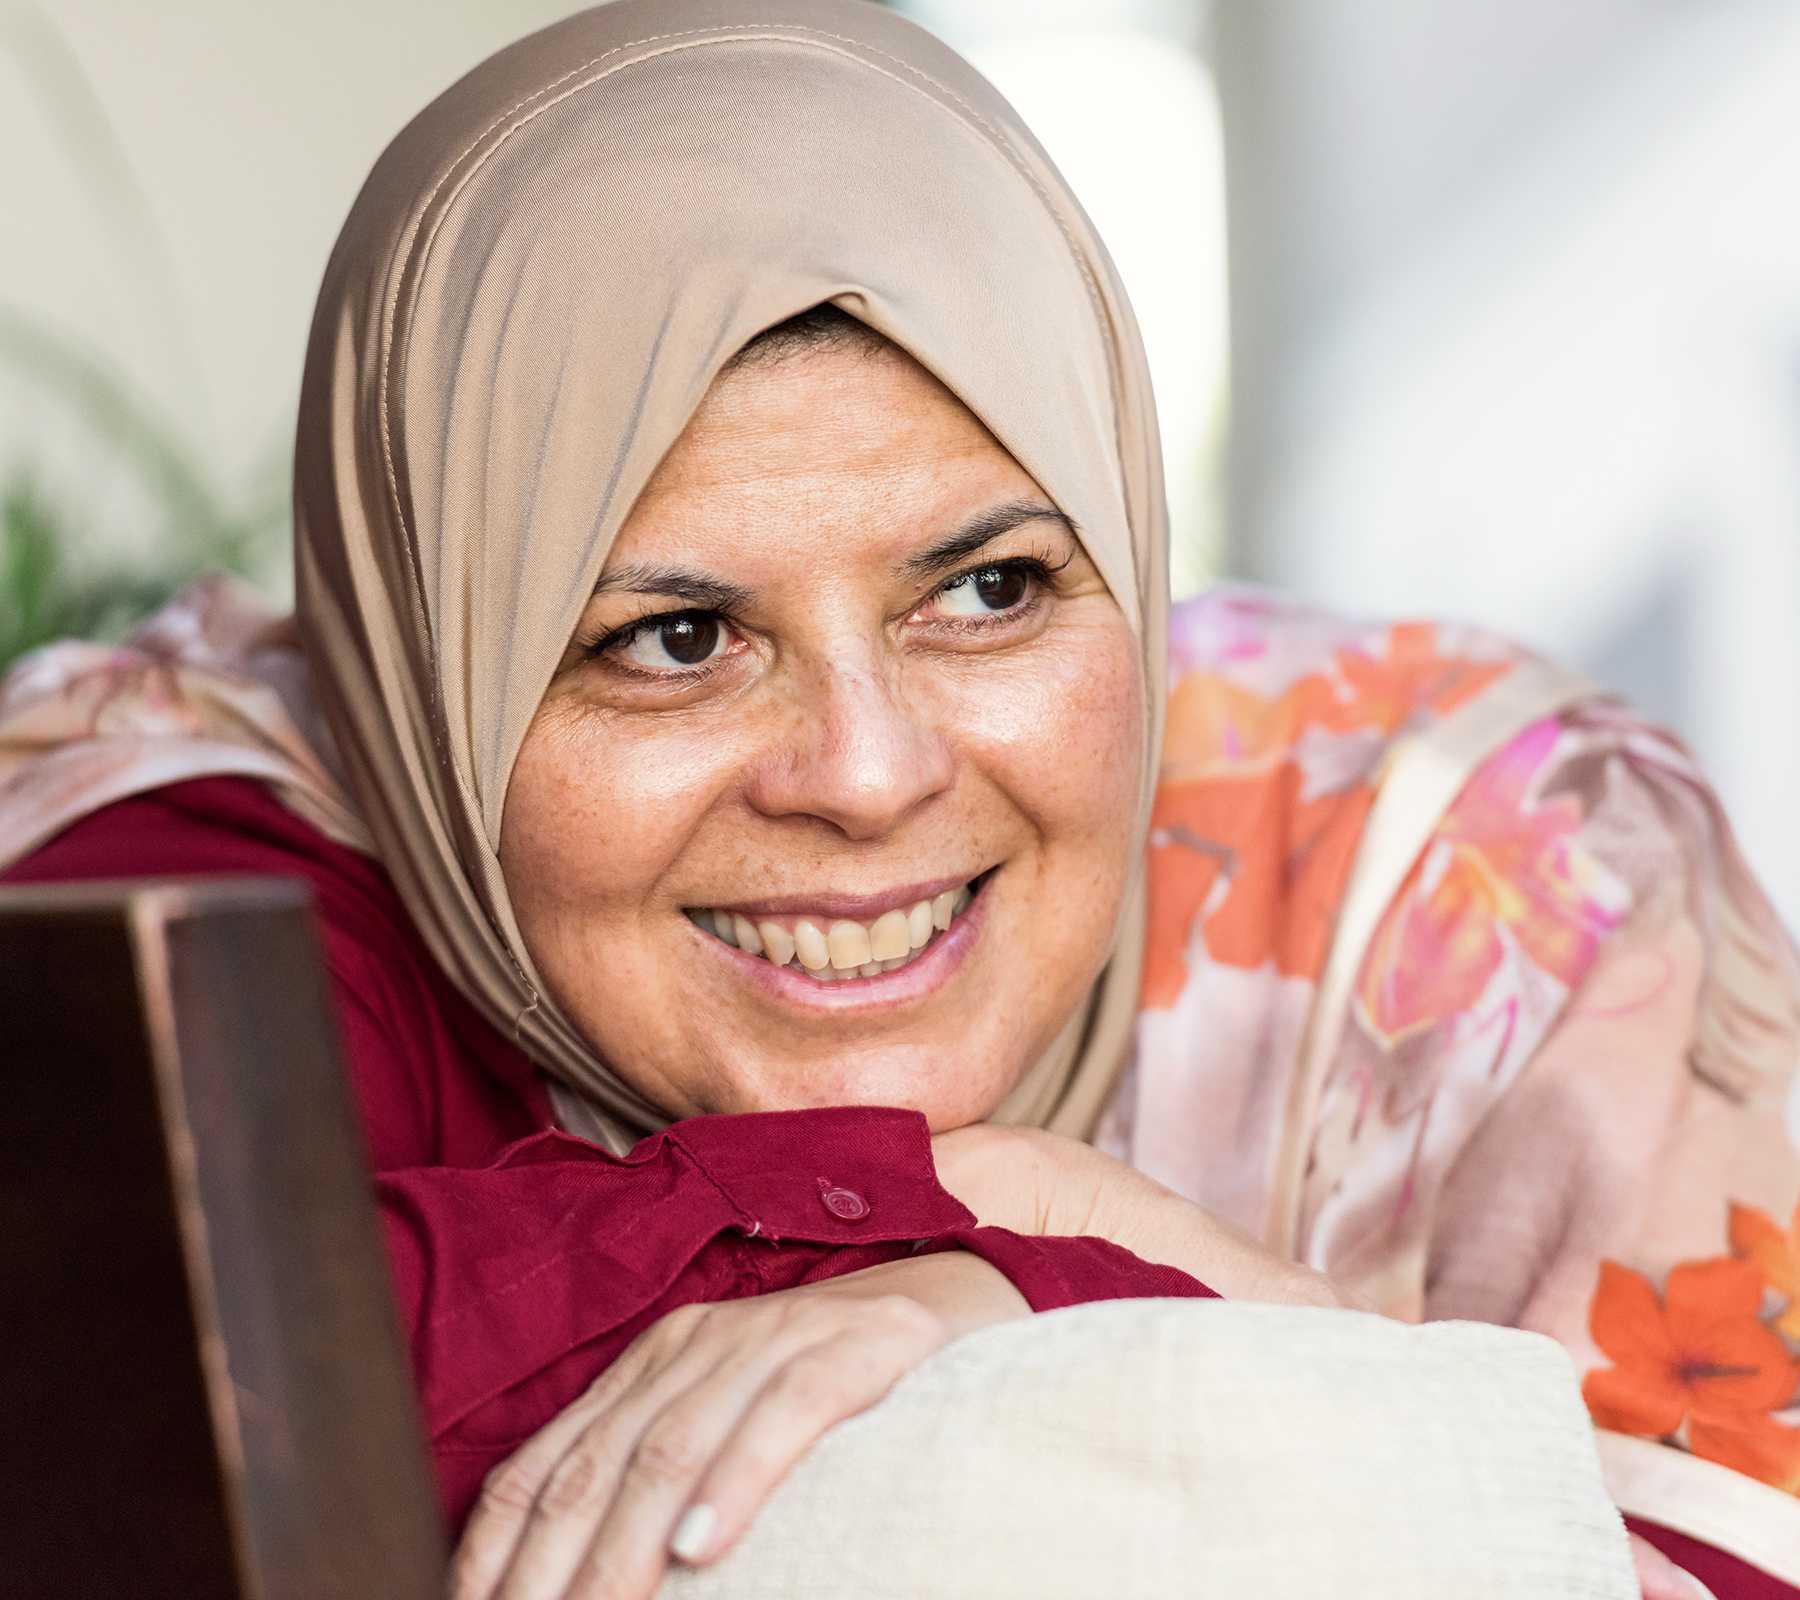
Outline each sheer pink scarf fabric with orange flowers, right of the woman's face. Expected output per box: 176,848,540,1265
1098,589,1800,1550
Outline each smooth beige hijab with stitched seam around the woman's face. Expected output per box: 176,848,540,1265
295,0,1166,1148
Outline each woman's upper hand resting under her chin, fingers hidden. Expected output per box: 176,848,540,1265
931,1123,1375,1310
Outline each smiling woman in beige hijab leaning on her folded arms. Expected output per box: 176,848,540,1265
0,0,1800,1595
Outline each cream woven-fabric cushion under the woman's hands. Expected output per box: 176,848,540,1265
659,1299,1638,1600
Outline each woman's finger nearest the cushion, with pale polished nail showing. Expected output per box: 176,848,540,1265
675,1296,949,1564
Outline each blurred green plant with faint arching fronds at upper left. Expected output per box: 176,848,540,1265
0,4,286,668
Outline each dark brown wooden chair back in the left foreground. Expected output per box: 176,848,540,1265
0,880,445,1600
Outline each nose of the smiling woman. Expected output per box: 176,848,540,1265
749,668,954,839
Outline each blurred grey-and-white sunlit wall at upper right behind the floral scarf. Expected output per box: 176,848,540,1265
1217,0,1800,923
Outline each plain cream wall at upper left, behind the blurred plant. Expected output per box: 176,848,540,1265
0,0,571,586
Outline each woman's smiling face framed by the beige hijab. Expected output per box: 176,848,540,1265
500,336,1145,1130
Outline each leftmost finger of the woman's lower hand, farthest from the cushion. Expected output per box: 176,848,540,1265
450,1307,704,1600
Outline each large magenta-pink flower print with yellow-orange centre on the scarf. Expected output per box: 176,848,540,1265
1357,718,1618,1046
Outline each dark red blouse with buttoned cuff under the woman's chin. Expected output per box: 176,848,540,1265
4,778,1211,1532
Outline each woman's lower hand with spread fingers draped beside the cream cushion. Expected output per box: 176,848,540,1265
450,1251,1028,1600
